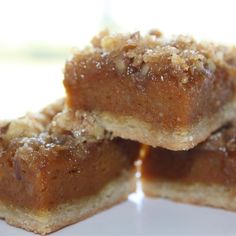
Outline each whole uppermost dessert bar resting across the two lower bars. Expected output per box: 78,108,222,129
64,31,236,150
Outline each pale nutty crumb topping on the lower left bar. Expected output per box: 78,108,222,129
0,100,107,163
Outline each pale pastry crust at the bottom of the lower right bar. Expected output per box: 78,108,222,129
142,179,236,211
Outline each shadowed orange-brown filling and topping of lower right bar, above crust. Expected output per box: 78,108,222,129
142,124,236,185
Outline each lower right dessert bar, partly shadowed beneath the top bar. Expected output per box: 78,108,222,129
142,124,236,211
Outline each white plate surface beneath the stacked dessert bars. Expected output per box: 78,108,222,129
0,188,236,236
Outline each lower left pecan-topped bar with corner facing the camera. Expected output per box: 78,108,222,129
0,99,139,234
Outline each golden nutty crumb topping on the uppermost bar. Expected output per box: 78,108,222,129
68,30,236,85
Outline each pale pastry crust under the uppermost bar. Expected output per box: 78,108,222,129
84,102,236,151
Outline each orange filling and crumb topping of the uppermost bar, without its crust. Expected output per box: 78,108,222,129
64,30,236,130
